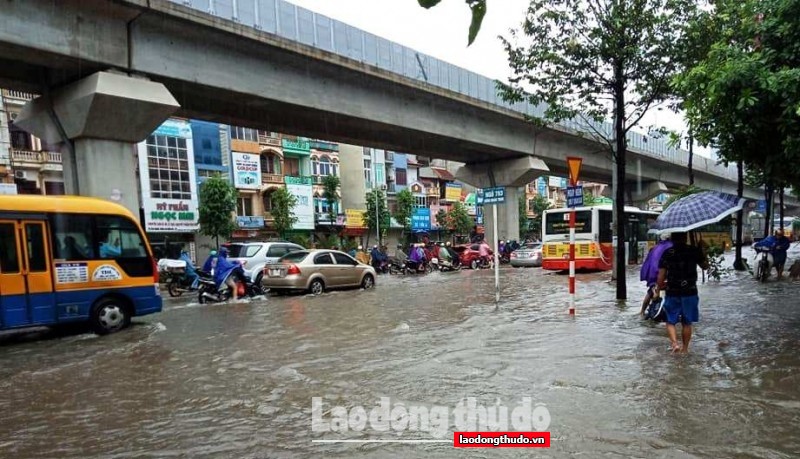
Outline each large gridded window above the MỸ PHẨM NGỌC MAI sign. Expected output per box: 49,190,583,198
145,135,192,200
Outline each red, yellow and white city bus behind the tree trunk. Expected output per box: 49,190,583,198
542,205,658,271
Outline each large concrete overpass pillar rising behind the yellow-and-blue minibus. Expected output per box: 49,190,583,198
16,72,180,216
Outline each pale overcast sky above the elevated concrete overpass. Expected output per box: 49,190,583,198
288,0,708,156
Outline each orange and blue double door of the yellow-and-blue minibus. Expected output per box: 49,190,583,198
0,220,56,328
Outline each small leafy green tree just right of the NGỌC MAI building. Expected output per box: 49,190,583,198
199,174,236,249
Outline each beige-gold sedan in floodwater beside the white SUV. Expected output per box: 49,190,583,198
264,249,377,295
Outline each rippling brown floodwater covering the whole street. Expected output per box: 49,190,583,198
0,246,800,458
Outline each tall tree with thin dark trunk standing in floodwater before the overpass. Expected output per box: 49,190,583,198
499,0,696,300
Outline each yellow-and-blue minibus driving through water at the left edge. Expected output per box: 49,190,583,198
0,195,162,334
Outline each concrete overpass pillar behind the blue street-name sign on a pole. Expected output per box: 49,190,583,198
456,156,550,246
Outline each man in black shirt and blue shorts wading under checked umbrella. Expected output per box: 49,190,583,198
658,233,708,353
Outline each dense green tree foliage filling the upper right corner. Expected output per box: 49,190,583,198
673,0,800,189
